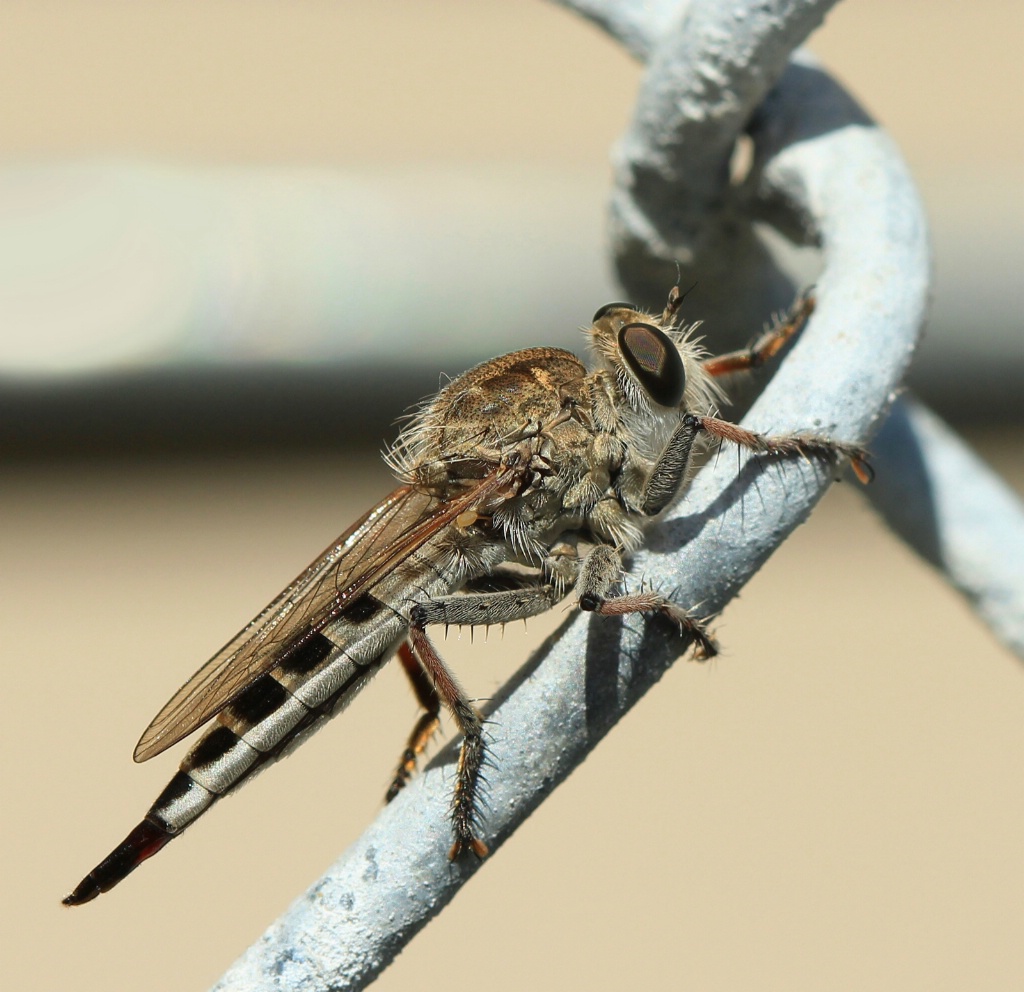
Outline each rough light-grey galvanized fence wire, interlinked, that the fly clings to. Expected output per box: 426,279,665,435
216,0,1024,992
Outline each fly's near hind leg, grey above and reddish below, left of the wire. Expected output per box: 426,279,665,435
409,581,560,860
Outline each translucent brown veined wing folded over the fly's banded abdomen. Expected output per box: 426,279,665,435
134,471,509,762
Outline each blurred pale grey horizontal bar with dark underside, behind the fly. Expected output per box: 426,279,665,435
0,162,1024,455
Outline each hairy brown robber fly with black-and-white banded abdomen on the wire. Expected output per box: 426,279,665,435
65,287,868,906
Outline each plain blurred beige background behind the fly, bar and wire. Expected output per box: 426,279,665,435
0,0,1024,992
